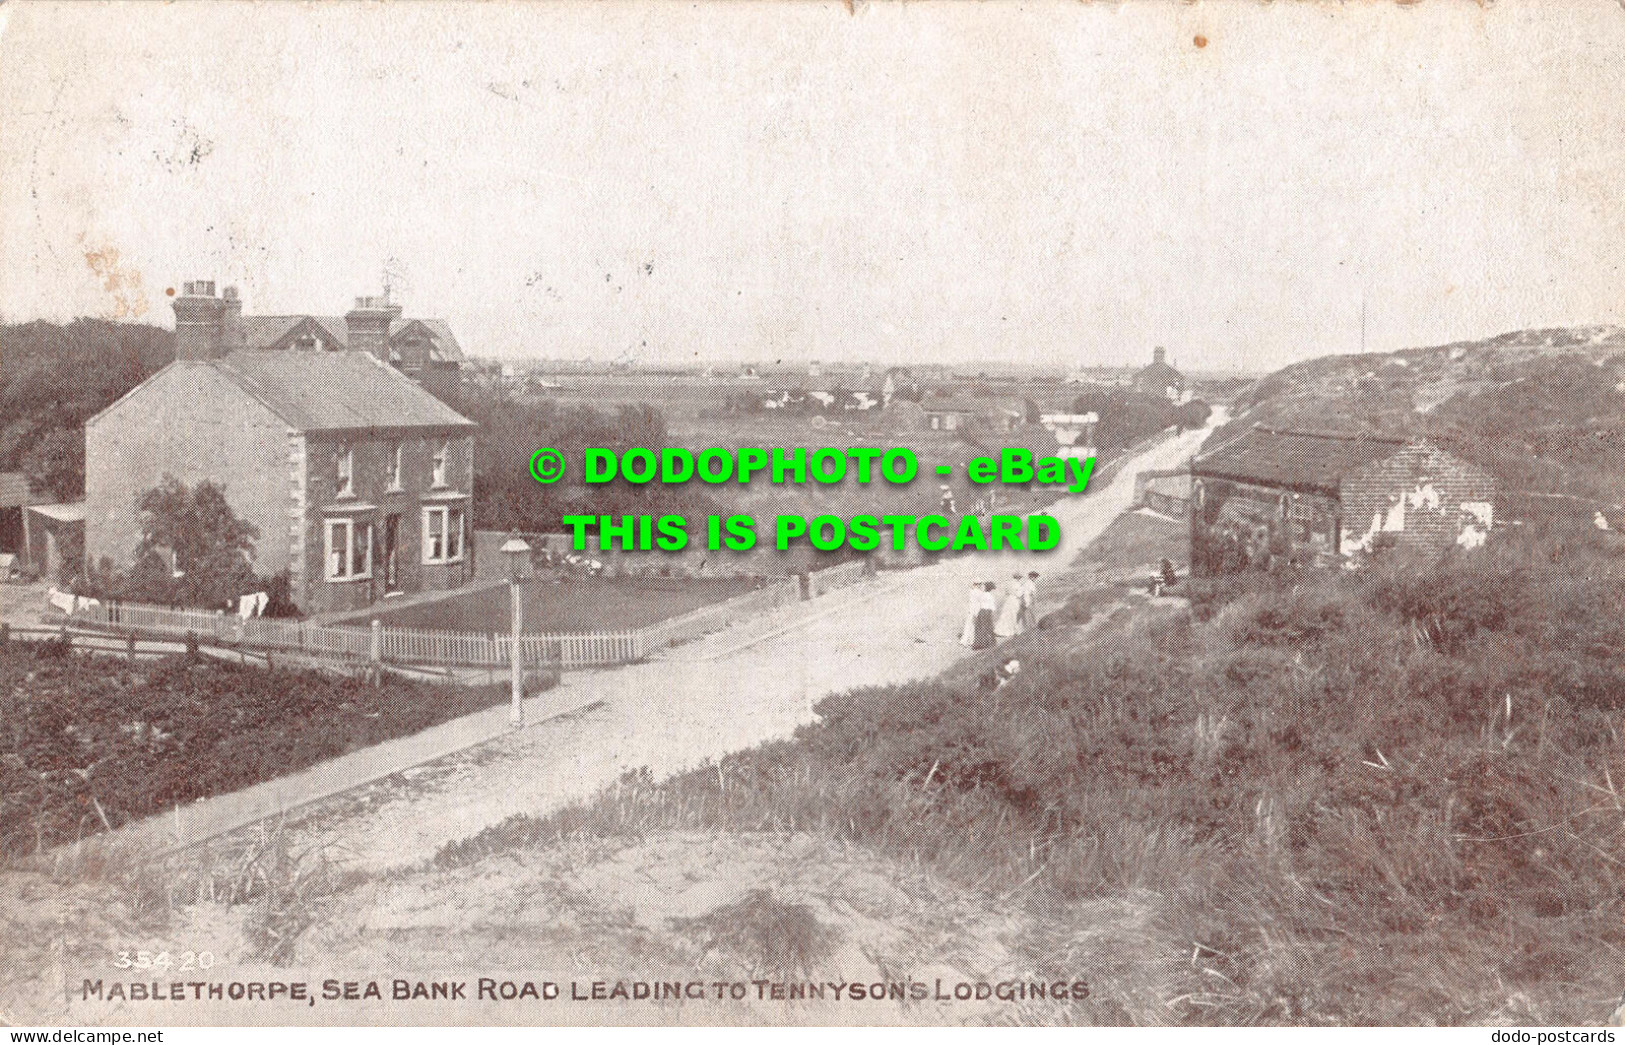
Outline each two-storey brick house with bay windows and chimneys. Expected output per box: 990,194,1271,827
85,284,475,613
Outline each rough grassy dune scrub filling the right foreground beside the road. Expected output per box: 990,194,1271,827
437,520,1625,1024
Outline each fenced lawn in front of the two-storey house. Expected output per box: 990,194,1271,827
365,577,754,634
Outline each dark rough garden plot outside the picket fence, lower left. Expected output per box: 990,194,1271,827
0,642,505,858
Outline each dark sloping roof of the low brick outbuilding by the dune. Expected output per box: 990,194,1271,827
1191,426,1407,492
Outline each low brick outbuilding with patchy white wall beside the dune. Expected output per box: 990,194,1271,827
1190,426,1495,570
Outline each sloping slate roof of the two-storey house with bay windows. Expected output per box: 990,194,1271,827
211,349,475,432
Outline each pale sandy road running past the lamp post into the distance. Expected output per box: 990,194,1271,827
282,429,1207,869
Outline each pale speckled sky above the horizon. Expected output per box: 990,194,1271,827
0,0,1625,369
